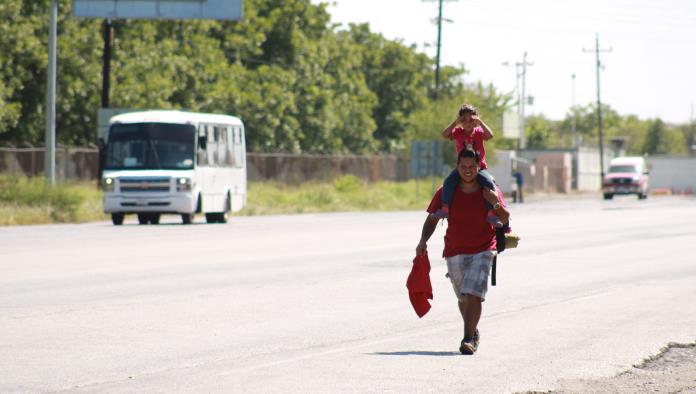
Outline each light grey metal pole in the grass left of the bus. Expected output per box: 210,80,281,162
44,0,58,185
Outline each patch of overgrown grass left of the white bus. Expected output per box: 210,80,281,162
0,175,107,225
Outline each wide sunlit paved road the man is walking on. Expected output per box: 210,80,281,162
0,197,696,393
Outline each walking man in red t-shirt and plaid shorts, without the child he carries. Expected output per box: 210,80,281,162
416,149,510,354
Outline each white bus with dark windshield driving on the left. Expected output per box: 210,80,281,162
102,111,247,225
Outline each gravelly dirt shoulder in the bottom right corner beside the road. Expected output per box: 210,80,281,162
528,342,696,394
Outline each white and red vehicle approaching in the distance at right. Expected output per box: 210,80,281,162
602,156,650,200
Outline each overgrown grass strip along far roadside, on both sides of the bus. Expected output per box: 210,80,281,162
0,175,441,226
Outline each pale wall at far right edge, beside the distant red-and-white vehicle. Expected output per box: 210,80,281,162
647,156,696,193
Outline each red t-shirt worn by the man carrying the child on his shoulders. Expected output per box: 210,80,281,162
427,186,495,257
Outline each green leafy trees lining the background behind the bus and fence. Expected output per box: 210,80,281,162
0,0,694,154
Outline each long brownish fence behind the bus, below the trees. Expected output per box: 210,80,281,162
0,147,409,184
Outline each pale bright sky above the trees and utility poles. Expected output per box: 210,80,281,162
312,0,696,123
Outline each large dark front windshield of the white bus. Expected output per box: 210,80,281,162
104,123,196,170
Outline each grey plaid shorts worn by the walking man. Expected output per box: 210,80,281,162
445,250,496,301
